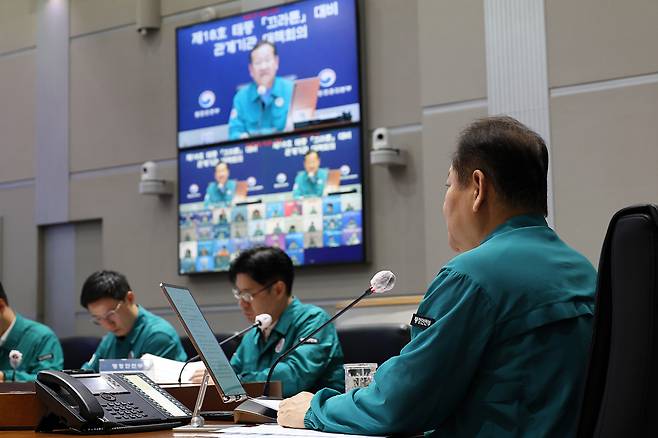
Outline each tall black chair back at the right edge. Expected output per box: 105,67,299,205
578,205,658,438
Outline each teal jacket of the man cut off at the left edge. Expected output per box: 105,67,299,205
0,314,64,382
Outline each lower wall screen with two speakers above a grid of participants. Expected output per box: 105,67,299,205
178,125,364,274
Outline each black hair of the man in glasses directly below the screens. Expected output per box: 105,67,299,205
228,246,295,295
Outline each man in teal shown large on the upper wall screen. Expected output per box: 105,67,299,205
228,40,295,140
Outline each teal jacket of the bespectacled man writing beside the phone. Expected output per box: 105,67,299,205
80,306,187,372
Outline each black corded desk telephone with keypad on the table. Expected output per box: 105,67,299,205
35,371,192,435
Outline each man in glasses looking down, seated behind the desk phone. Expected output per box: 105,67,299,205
80,271,187,372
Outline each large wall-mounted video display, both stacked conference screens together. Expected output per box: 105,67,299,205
176,0,365,274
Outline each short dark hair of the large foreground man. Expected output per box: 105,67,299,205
452,116,548,216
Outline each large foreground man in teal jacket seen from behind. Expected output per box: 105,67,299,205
279,117,596,437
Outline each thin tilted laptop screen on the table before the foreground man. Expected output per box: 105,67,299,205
160,283,279,423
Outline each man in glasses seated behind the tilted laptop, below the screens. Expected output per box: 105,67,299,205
229,247,344,397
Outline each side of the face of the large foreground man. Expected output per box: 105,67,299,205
443,166,478,252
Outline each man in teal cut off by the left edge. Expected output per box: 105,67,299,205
0,283,64,382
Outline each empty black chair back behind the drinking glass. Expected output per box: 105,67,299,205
337,324,411,365
